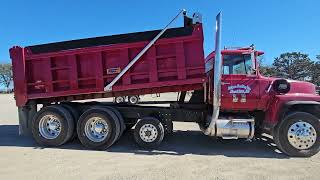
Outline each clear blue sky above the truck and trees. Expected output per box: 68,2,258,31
0,0,320,63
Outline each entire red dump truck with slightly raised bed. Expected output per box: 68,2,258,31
10,11,320,157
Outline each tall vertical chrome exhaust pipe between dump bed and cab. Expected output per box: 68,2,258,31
202,12,222,136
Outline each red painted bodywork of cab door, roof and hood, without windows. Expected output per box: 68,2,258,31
205,48,320,124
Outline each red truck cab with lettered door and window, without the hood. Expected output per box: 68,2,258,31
206,47,269,111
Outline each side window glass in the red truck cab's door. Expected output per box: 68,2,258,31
223,54,253,74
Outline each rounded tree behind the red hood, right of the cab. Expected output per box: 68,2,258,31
273,52,313,81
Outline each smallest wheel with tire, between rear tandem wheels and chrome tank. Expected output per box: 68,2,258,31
134,117,164,149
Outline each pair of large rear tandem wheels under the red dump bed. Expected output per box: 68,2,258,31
32,105,125,150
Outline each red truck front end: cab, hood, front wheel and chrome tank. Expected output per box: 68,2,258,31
204,43,320,156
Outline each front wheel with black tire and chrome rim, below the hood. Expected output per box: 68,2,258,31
273,112,320,157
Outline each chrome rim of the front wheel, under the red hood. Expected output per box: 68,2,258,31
288,121,317,150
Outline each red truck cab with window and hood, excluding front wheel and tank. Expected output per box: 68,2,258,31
205,46,319,112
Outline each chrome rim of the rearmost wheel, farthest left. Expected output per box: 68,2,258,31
39,115,61,139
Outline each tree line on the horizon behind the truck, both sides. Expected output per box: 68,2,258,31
0,52,320,92
